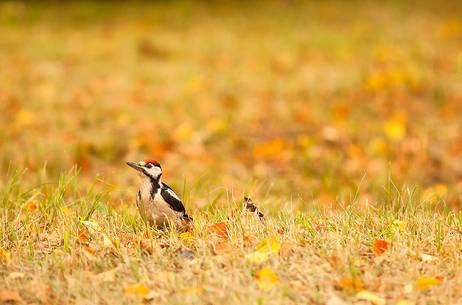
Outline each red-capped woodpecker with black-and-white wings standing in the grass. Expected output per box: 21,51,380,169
127,160,192,227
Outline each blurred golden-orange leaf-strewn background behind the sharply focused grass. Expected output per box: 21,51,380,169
0,1,462,210
